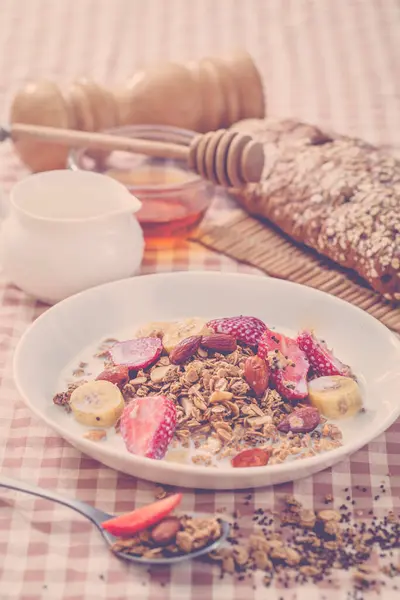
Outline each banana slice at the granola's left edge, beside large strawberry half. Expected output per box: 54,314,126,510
69,380,125,427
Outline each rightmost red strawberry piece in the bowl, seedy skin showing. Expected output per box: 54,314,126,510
297,331,351,377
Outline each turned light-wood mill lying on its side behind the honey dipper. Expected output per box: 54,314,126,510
10,53,265,171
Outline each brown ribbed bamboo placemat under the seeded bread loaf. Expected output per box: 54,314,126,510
192,211,400,333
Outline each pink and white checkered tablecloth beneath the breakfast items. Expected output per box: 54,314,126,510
0,0,400,600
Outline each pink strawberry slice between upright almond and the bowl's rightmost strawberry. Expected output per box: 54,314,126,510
258,329,310,400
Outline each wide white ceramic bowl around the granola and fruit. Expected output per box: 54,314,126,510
14,272,400,489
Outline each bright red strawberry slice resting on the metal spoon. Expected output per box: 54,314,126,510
101,494,182,536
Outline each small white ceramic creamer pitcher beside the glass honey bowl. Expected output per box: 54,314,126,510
0,170,144,304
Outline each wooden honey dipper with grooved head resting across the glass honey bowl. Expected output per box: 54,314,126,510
0,123,264,188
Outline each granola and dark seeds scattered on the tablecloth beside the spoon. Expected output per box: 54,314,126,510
206,496,400,600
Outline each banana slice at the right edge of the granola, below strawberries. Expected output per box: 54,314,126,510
308,375,362,419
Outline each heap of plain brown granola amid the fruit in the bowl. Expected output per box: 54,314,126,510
117,346,332,466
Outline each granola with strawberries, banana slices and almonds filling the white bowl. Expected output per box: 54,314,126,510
53,316,362,468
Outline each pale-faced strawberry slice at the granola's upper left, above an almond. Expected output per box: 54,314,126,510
109,338,163,369
